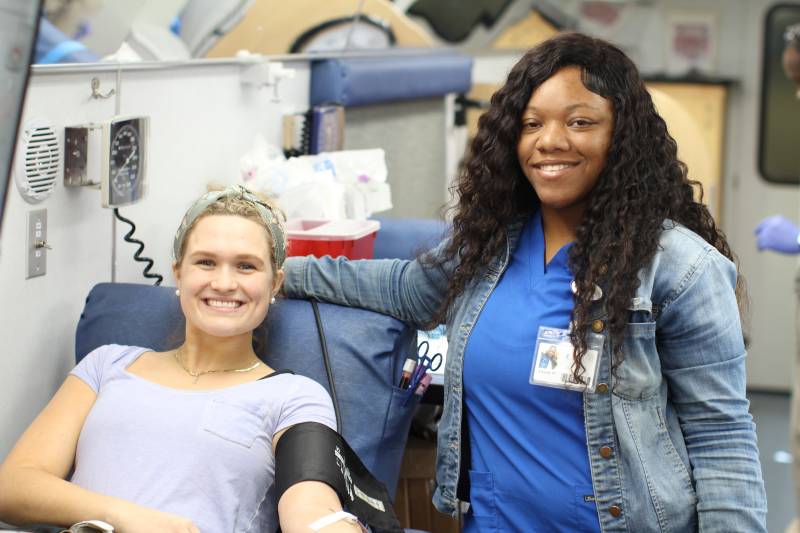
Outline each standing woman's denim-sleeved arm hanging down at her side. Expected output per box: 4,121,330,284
657,250,767,533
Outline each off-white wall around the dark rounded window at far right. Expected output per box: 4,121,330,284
720,0,800,390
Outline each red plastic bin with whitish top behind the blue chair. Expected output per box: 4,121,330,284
286,220,381,259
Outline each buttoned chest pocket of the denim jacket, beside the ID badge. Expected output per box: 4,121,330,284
613,297,662,400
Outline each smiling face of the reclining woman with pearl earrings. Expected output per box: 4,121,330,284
173,215,283,337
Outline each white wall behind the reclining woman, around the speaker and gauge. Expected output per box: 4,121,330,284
0,57,309,458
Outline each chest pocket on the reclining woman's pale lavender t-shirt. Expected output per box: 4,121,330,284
201,399,264,448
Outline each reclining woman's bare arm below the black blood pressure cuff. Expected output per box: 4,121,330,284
272,428,362,533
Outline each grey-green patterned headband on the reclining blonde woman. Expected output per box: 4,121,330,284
172,185,286,268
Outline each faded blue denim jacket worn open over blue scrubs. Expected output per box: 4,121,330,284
285,221,767,533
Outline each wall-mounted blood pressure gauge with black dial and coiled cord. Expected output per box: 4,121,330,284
100,117,149,207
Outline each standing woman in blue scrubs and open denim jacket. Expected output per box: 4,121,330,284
285,34,766,533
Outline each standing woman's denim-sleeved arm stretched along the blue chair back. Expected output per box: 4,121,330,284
284,241,451,326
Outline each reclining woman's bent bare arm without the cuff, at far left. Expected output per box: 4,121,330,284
0,376,199,533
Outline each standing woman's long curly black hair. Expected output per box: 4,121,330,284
424,33,742,382
